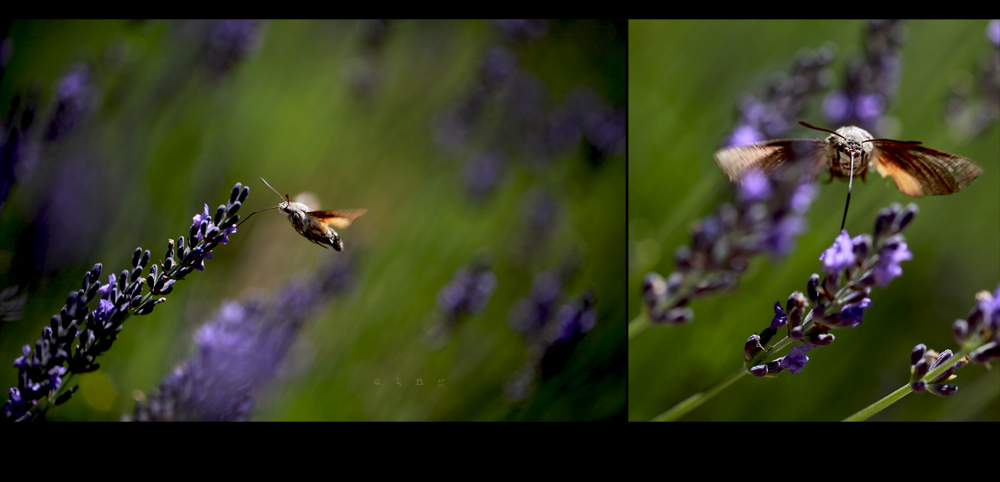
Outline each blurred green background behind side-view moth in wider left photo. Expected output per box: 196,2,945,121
0,21,624,420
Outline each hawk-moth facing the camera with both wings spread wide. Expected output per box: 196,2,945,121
715,121,983,198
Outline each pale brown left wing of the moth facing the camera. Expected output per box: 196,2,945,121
715,139,826,183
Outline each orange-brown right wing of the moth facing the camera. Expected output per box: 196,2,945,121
872,140,983,197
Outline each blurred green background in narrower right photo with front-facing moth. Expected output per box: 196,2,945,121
628,20,1000,421
